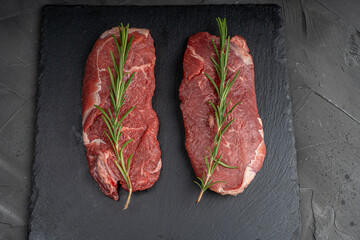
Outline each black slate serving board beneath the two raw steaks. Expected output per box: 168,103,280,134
29,5,299,240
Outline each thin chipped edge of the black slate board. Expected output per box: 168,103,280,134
28,4,301,239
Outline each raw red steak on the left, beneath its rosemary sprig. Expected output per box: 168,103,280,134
82,28,161,200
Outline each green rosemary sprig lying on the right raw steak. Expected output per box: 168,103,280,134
195,18,241,203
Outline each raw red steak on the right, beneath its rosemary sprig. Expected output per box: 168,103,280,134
179,32,266,195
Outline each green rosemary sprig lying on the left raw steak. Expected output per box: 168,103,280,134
95,23,135,210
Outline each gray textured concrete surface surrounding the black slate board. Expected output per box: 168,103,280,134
0,0,360,240
